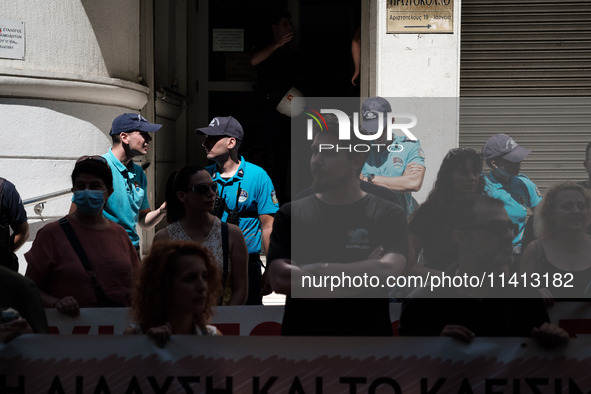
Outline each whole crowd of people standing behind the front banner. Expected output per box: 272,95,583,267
0,97,591,346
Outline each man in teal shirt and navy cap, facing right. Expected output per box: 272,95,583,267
103,114,166,251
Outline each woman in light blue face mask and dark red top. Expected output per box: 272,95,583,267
25,156,139,316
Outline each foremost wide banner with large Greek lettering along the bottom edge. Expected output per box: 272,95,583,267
0,335,591,394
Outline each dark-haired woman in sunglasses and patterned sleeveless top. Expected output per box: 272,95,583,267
154,166,248,305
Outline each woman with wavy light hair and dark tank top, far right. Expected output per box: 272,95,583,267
520,182,591,304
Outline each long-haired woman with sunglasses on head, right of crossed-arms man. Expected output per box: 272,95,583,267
408,148,484,276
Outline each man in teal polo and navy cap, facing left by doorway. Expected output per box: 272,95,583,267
195,116,279,305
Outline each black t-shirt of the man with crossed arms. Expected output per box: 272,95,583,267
267,194,408,336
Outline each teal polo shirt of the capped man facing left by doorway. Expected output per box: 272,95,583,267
206,157,279,253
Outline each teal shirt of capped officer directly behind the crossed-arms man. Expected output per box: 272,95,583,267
361,136,425,213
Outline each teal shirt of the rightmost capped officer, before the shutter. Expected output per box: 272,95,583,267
484,172,542,251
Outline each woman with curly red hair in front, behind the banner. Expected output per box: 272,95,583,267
124,241,221,347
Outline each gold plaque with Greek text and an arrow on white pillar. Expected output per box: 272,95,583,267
386,0,454,34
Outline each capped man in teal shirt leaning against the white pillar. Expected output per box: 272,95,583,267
361,97,425,215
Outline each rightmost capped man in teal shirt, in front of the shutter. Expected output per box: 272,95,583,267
482,133,542,265
